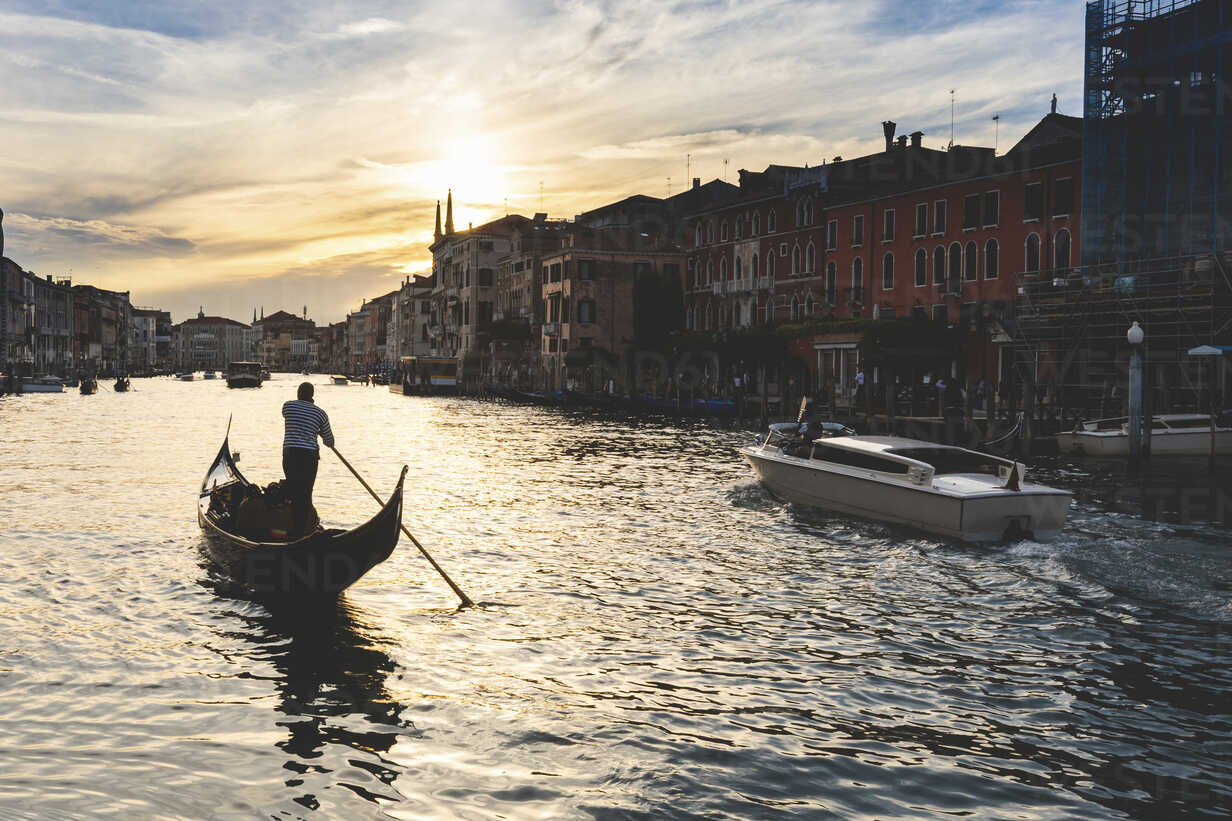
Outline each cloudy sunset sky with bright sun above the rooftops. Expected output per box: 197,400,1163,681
0,0,1083,323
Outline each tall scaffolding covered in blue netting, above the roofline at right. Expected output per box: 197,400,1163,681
1082,0,1232,264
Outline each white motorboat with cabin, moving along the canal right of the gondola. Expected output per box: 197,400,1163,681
740,423,1071,542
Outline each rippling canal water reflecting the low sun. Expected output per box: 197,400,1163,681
0,375,1232,820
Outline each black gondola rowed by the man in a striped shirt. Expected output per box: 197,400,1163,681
197,428,407,595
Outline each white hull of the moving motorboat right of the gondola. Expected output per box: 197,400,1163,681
742,447,1071,542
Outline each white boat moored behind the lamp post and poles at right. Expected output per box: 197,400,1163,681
1057,413,1232,459
